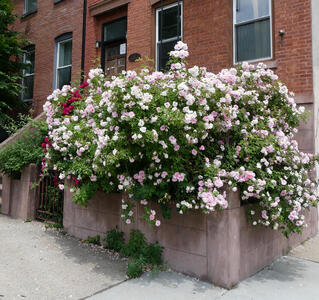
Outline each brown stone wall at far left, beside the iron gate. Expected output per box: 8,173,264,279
1,164,38,220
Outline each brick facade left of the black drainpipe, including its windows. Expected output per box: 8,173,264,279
12,0,83,115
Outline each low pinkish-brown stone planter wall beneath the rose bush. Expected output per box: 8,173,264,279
63,189,318,288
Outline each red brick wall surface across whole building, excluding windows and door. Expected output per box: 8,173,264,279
14,0,313,114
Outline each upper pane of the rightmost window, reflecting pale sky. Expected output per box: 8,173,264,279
236,0,270,23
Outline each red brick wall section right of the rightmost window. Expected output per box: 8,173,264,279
273,0,313,100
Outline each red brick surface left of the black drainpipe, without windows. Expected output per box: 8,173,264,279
13,0,83,115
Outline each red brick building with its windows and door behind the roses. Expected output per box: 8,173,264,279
13,0,318,155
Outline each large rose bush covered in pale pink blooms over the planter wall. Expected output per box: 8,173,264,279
43,42,318,235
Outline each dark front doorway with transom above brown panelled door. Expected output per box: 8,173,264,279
101,17,127,76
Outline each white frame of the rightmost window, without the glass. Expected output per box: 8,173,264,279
233,0,273,65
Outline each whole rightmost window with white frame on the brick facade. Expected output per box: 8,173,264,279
233,0,272,63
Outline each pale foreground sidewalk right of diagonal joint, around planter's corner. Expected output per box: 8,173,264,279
88,256,319,300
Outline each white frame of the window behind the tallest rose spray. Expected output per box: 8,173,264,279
155,1,184,71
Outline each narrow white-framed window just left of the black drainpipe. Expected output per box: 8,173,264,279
53,33,72,89
